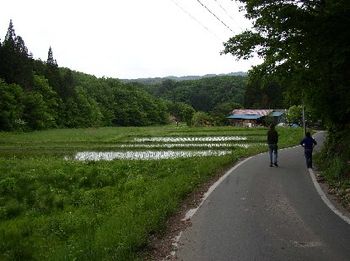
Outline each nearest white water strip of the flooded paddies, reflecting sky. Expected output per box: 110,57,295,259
74,150,231,161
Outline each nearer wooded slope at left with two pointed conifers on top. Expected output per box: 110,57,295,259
0,21,168,130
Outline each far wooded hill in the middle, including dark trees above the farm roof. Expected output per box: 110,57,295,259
131,73,291,125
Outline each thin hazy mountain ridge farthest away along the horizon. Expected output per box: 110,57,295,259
120,72,247,84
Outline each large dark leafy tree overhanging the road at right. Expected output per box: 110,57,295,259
224,0,350,126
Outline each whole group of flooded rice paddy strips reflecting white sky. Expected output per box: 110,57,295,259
66,136,262,161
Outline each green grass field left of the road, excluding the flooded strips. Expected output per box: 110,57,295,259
0,126,302,260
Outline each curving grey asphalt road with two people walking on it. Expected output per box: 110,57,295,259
176,132,350,261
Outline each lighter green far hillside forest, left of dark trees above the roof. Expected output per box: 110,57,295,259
140,76,246,125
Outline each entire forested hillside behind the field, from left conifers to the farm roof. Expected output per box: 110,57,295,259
0,21,282,131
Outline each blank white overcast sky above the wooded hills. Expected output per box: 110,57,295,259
0,0,258,79
